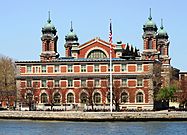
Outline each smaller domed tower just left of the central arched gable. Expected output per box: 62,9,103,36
64,22,79,58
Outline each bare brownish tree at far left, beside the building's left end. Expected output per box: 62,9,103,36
0,57,16,106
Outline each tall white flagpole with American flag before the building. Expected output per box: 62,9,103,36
109,19,113,112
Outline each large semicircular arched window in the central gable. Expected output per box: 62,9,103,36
87,50,106,59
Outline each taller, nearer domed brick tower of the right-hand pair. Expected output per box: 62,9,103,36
142,8,158,59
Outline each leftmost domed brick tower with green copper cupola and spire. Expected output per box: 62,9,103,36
40,12,59,61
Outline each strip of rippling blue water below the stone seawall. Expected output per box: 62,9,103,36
0,120,187,135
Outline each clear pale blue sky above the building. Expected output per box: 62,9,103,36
0,0,187,71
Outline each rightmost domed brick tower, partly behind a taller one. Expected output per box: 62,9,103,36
157,19,170,64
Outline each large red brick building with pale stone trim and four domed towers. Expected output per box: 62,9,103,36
16,10,171,110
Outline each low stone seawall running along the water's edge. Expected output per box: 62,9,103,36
0,111,187,121
